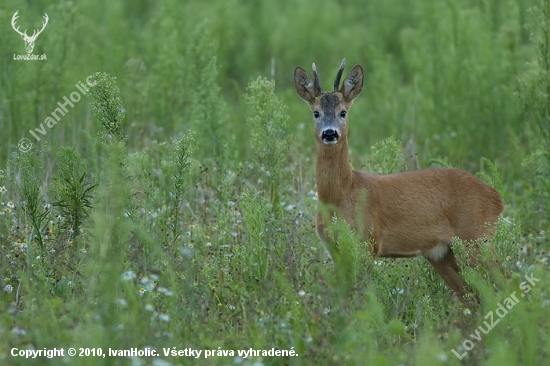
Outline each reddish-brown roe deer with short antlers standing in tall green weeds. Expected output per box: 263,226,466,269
294,59,504,297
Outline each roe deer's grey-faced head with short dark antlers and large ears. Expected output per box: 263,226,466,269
294,59,363,145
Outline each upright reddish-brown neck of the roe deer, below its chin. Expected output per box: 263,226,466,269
315,136,352,206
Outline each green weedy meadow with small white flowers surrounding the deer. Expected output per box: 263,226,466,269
0,0,550,366
